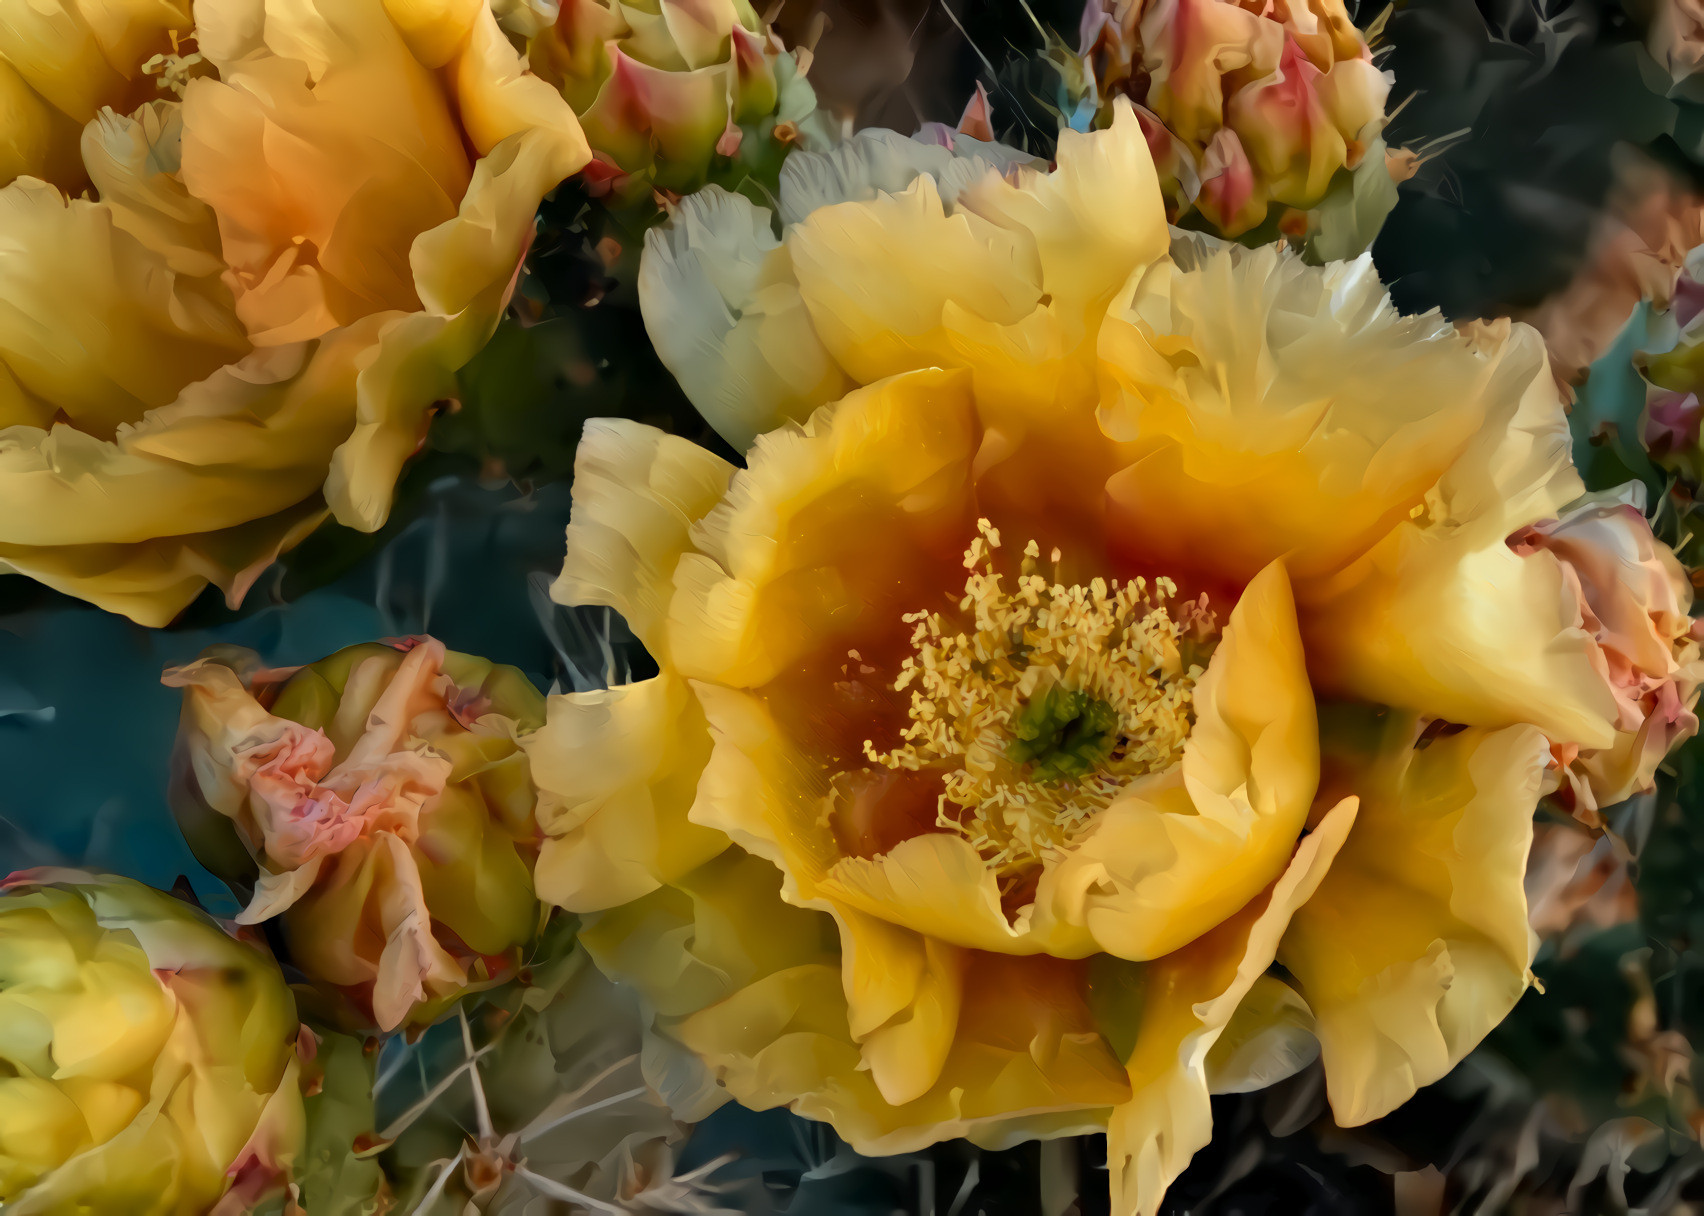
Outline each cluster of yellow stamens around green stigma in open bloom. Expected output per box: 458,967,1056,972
864,519,1218,880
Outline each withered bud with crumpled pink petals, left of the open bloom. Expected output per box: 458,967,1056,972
165,639,544,1030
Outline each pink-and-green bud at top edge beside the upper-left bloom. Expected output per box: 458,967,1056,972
528,0,828,201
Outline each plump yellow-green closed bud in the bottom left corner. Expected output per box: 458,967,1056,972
0,869,303,1216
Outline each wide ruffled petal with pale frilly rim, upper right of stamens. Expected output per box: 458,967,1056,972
1099,237,1561,585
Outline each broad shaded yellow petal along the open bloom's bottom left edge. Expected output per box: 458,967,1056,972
606,850,1128,1153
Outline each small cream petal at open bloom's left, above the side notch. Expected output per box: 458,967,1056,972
550,419,734,662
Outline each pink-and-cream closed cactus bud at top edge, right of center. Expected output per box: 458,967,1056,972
1080,0,1401,246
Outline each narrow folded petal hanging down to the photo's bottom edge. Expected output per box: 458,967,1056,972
1106,799,1355,1216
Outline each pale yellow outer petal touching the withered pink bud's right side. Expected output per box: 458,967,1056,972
521,671,729,913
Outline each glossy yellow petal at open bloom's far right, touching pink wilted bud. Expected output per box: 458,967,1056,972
1297,316,1617,748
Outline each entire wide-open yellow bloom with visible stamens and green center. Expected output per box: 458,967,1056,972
530,106,1649,1213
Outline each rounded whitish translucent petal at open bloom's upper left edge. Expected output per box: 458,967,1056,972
639,187,850,451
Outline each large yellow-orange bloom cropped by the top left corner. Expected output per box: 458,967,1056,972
0,0,588,625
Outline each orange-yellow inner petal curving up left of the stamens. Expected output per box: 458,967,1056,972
668,370,976,688
